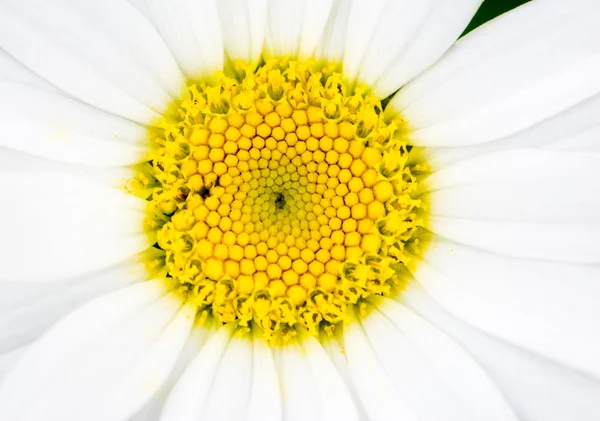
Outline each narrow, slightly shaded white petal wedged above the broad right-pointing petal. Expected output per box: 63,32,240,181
427,95,600,169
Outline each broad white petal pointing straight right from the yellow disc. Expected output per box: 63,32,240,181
426,150,600,262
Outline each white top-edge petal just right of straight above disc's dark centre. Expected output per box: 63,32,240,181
265,0,333,59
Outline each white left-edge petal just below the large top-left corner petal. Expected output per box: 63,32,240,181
0,81,149,166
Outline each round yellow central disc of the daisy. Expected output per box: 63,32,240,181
136,59,423,339
